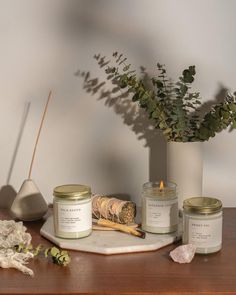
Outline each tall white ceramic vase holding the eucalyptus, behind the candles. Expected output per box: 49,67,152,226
167,142,203,211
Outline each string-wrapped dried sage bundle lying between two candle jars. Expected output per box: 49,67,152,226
92,195,136,224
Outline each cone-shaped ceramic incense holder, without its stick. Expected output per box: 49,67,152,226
10,179,48,221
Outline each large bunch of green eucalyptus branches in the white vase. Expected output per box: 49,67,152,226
91,52,236,142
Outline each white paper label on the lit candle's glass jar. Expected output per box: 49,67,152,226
146,198,178,227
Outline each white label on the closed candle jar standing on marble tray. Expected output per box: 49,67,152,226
57,202,92,232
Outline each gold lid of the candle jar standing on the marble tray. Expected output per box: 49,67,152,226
53,184,91,200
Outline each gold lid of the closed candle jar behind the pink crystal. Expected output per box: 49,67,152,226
183,197,222,214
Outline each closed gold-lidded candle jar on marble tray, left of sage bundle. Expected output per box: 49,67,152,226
53,184,92,239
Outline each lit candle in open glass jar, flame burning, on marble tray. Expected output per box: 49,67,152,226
142,182,178,233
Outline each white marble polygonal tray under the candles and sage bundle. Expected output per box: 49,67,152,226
40,216,180,255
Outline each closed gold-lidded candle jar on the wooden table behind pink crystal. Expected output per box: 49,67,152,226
183,197,222,254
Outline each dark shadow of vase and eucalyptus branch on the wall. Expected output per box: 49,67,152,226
75,71,166,181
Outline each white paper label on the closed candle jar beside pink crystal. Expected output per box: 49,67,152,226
188,216,222,248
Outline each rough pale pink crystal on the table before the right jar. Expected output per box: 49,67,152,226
170,244,196,263
